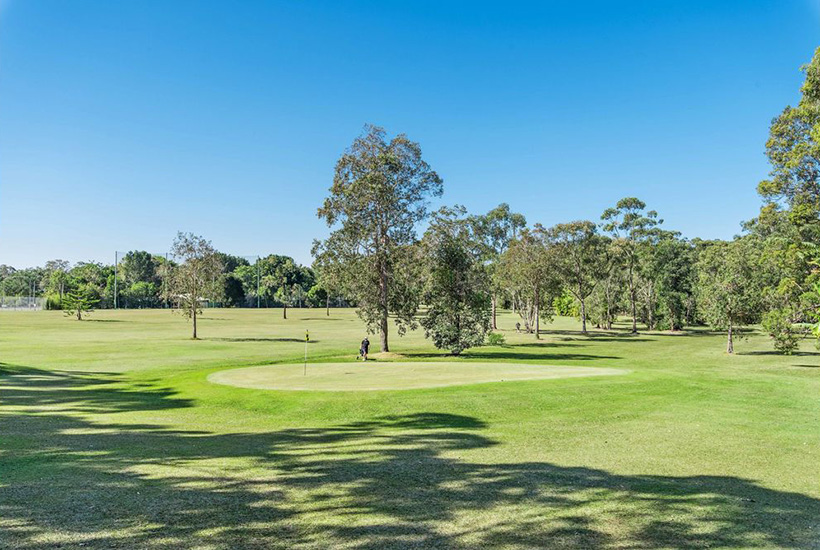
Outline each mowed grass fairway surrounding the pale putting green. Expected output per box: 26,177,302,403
0,310,820,550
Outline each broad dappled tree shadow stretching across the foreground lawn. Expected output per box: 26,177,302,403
0,365,820,550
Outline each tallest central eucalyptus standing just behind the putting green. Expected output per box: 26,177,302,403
314,126,443,352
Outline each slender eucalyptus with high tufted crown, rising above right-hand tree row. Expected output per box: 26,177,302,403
601,197,663,333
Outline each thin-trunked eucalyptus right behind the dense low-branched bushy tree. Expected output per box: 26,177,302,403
470,203,527,329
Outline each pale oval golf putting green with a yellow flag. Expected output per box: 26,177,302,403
208,361,628,391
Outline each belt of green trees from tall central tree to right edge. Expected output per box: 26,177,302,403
313,45,820,353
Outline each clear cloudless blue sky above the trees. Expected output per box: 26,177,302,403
0,0,820,267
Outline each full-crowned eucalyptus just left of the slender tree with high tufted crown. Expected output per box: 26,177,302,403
546,221,609,333
